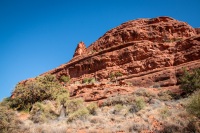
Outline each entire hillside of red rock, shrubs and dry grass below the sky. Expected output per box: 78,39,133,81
0,17,200,133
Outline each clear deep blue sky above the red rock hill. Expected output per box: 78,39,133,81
0,0,200,101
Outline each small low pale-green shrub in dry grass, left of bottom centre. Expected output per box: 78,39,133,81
67,107,89,122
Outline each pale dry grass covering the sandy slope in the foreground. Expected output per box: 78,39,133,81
3,89,200,133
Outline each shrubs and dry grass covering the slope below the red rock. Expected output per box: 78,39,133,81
0,69,200,132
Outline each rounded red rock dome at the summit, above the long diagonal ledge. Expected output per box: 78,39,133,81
88,17,196,51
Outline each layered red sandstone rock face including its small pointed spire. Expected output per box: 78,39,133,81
20,17,200,101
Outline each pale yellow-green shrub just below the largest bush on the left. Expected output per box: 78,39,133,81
30,101,58,123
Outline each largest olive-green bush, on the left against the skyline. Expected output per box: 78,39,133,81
11,75,68,110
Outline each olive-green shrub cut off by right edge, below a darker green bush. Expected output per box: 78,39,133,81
186,90,200,118
